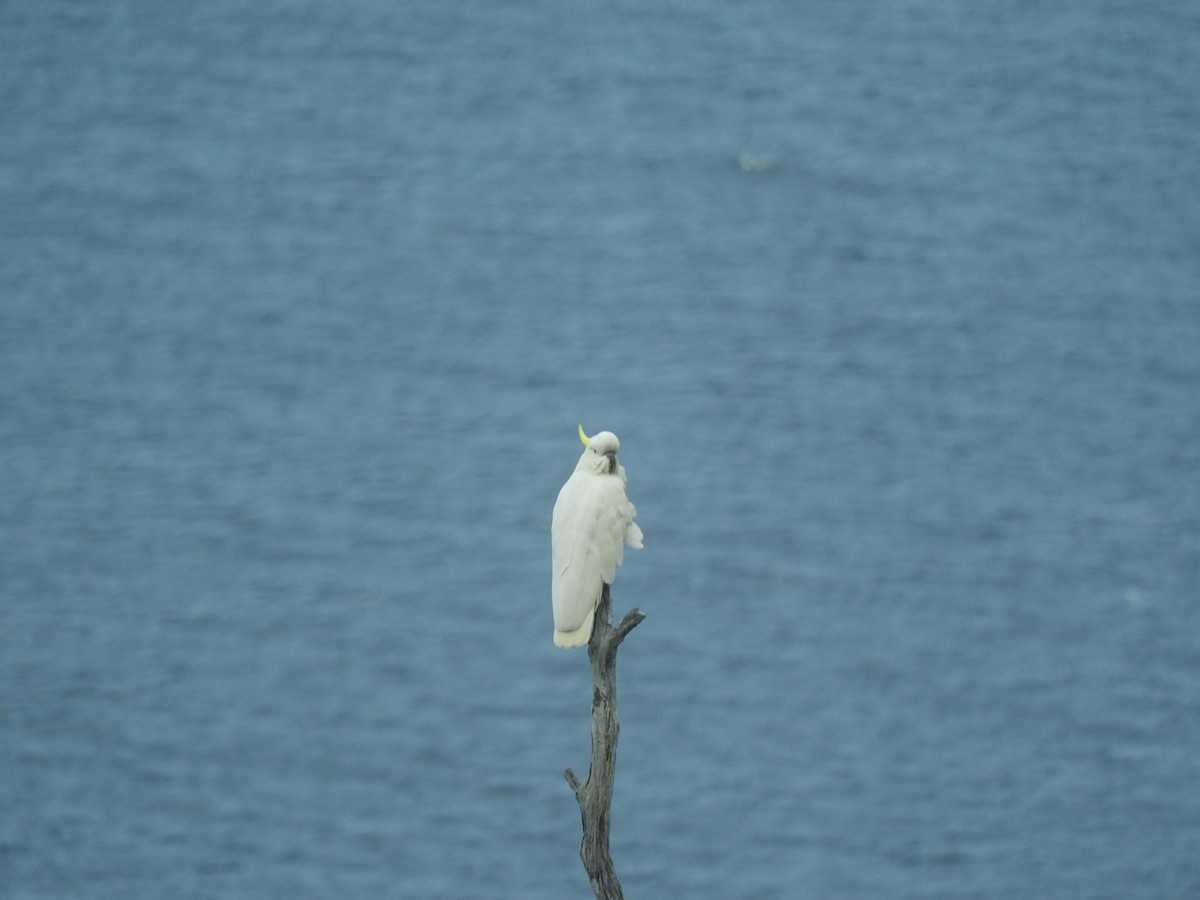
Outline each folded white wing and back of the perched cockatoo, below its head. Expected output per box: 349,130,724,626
551,472,642,631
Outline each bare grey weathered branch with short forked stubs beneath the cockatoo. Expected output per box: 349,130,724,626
565,584,646,900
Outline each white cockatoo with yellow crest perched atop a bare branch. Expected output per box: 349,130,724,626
550,425,642,647
